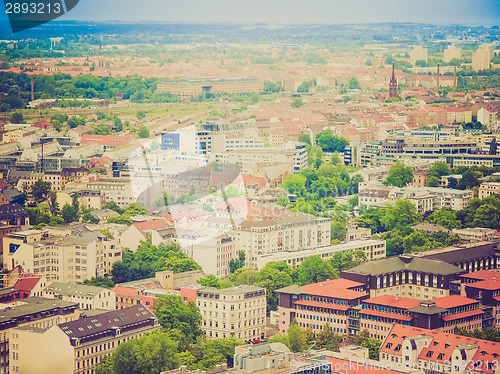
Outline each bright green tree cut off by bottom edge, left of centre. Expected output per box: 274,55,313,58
112,332,180,374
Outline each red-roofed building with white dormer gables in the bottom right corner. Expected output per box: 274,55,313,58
380,324,500,374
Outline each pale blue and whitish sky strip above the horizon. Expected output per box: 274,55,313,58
56,0,500,26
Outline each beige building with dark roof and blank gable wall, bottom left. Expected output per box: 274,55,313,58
9,305,158,374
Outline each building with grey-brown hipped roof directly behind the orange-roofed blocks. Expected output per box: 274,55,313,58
340,255,465,300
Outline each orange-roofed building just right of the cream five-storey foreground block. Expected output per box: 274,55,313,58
276,278,369,335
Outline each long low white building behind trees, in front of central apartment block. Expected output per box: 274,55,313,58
254,239,386,270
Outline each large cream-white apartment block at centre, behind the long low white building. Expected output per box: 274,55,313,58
234,212,331,268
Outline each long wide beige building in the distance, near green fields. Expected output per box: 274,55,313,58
156,78,264,98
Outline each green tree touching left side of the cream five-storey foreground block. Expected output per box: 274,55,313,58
154,295,203,342
